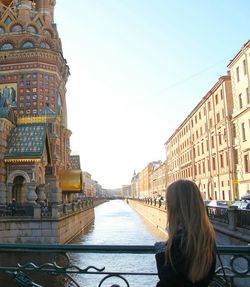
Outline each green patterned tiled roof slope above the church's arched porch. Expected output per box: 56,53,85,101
5,124,46,159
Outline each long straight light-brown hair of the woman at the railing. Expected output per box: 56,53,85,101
166,180,215,282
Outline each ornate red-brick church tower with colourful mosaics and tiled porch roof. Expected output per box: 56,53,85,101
0,0,81,209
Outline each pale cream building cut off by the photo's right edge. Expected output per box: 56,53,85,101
228,41,250,197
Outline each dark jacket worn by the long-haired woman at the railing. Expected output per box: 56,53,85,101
155,236,216,287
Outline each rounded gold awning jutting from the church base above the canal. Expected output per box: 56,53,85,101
60,169,83,192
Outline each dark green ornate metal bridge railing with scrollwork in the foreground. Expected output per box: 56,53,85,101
0,243,250,287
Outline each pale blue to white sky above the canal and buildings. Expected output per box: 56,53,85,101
55,0,250,188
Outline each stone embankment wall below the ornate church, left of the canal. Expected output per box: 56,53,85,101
0,200,105,244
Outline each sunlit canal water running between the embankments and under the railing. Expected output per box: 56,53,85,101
68,200,166,287
